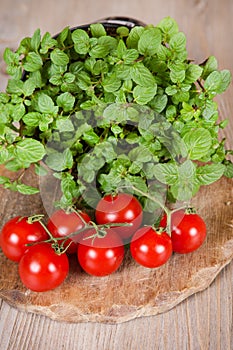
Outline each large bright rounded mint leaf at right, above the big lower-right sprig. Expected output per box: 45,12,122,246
183,128,212,160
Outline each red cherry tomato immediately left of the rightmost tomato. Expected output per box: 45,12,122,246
130,226,172,268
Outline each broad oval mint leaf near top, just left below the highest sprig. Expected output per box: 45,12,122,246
138,28,161,56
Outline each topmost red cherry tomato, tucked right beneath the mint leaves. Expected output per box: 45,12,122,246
95,193,143,240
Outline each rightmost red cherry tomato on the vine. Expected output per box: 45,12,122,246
160,210,206,254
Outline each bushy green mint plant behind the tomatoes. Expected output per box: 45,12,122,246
0,17,233,212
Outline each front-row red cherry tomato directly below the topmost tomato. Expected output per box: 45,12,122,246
78,228,124,276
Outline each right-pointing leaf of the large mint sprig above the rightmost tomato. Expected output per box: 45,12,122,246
196,164,225,185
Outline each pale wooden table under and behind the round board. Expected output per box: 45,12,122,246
0,0,233,350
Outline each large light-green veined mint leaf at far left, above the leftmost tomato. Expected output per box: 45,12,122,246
15,138,45,163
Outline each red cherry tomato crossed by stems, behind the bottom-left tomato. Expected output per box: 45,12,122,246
47,209,91,254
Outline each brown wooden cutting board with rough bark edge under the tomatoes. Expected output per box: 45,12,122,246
0,168,233,323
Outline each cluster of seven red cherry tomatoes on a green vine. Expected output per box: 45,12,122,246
0,193,206,292
